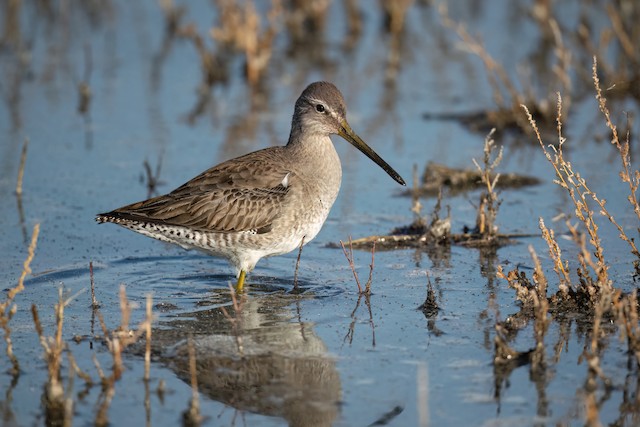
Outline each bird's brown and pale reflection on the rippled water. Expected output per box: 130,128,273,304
152,290,341,426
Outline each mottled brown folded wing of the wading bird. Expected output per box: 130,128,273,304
105,147,291,232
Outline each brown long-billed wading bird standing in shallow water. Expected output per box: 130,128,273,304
96,82,405,290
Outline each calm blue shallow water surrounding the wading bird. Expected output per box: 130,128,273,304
0,1,638,426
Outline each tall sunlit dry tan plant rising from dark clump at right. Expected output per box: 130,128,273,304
505,59,640,309
